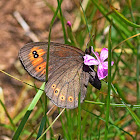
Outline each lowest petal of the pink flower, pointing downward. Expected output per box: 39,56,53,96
97,64,108,80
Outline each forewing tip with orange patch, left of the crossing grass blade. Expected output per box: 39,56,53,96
19,43,47,81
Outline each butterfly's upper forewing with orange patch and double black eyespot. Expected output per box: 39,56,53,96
19,42,84,81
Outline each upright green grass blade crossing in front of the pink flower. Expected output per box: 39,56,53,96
105,22,111,140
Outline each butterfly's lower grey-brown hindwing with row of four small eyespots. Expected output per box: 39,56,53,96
45,60,89,109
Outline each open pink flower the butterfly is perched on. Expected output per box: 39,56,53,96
83,48,114,80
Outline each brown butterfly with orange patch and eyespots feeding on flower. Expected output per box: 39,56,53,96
19,42,101,109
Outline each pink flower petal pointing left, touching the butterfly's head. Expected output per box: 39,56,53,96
83,54,99,66
